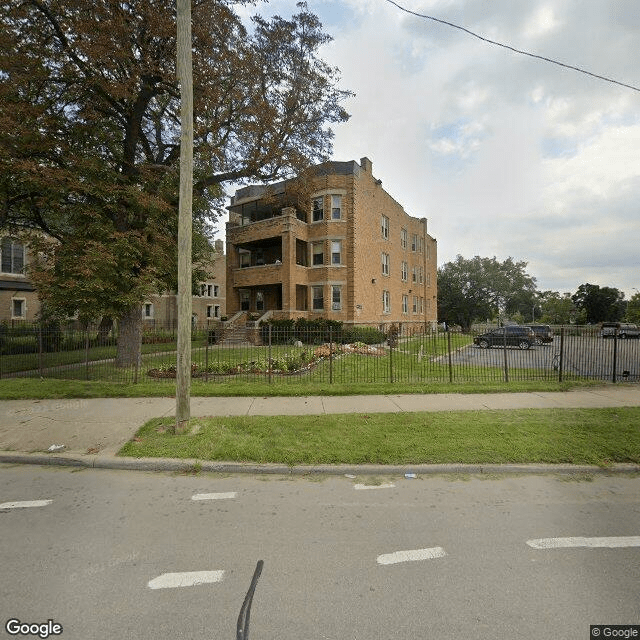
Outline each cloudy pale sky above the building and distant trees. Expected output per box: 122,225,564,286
226,0,640,298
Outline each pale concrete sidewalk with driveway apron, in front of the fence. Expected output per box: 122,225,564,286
0,384,640,476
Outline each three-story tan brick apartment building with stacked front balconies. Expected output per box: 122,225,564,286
226,158,437,324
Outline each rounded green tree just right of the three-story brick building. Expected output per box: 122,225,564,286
438,255,536,331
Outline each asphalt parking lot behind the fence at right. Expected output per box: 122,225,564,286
452,336,640,382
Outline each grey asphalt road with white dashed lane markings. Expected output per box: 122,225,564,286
0,465,640,640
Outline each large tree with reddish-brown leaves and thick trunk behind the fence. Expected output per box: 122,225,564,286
0,0,351,365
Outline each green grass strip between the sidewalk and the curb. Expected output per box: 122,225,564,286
120,407,640,466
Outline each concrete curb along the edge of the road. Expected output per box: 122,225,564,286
0,452,640,476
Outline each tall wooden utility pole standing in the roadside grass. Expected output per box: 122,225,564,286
175,0,193,433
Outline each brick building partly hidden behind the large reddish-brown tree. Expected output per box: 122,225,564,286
0,236,226,327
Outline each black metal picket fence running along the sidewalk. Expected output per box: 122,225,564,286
0,323,640,385
